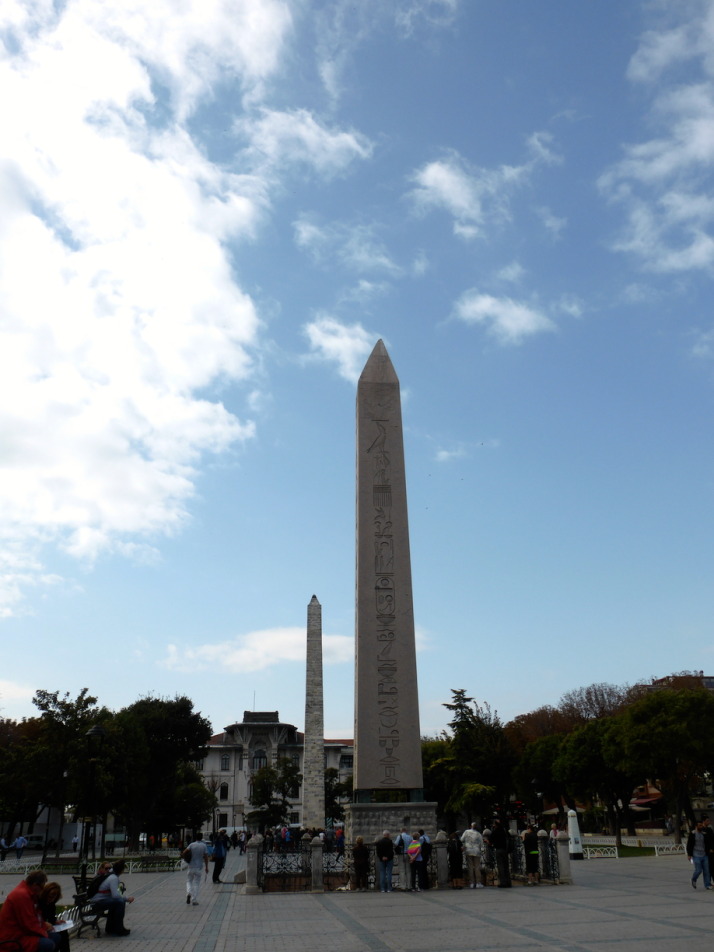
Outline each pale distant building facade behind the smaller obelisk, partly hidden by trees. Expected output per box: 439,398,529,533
198,711,354,832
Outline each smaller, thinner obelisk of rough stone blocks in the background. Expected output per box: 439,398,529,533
302,595,325,830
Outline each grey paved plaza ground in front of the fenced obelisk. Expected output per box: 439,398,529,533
0,850,714,952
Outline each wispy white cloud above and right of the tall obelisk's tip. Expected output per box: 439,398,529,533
410,132,560,240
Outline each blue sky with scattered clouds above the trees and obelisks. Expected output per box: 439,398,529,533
0,0,714,737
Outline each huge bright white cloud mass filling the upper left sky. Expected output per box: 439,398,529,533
0,0,306,614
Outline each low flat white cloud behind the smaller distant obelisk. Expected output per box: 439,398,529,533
162,627,354,674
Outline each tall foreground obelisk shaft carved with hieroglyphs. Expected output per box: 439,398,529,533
354,340,423,802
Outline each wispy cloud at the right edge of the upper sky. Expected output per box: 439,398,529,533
599,7,714,272
